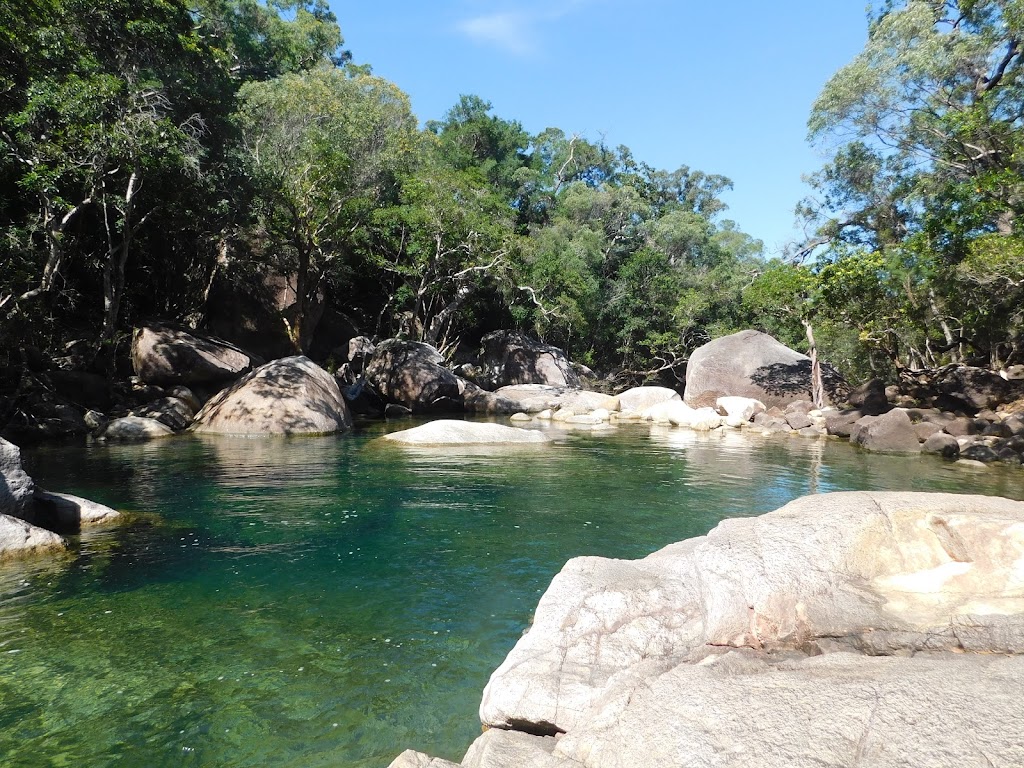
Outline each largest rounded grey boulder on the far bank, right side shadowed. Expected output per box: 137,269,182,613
683,331,845,415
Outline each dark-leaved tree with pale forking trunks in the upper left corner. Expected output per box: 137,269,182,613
0,0,218,348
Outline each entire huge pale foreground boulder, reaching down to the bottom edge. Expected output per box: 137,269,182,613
446,493,1024,768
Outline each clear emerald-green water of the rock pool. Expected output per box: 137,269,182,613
0,423,1024,768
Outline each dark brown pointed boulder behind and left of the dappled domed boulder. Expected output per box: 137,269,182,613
131,326,261,385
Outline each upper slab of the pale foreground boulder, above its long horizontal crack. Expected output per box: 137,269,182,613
480,493,1024,732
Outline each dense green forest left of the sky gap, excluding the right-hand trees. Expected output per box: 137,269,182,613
0,0,765,378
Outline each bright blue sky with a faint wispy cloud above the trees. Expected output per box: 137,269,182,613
331,0,866,255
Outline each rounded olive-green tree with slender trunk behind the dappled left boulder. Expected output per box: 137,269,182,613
239,65,416,350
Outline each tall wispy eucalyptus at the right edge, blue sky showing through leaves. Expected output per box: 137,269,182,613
802,0,1024,366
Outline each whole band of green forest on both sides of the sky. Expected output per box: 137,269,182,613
0,0,1024,382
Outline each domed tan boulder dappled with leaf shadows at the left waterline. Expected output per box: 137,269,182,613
193,356,352,435
